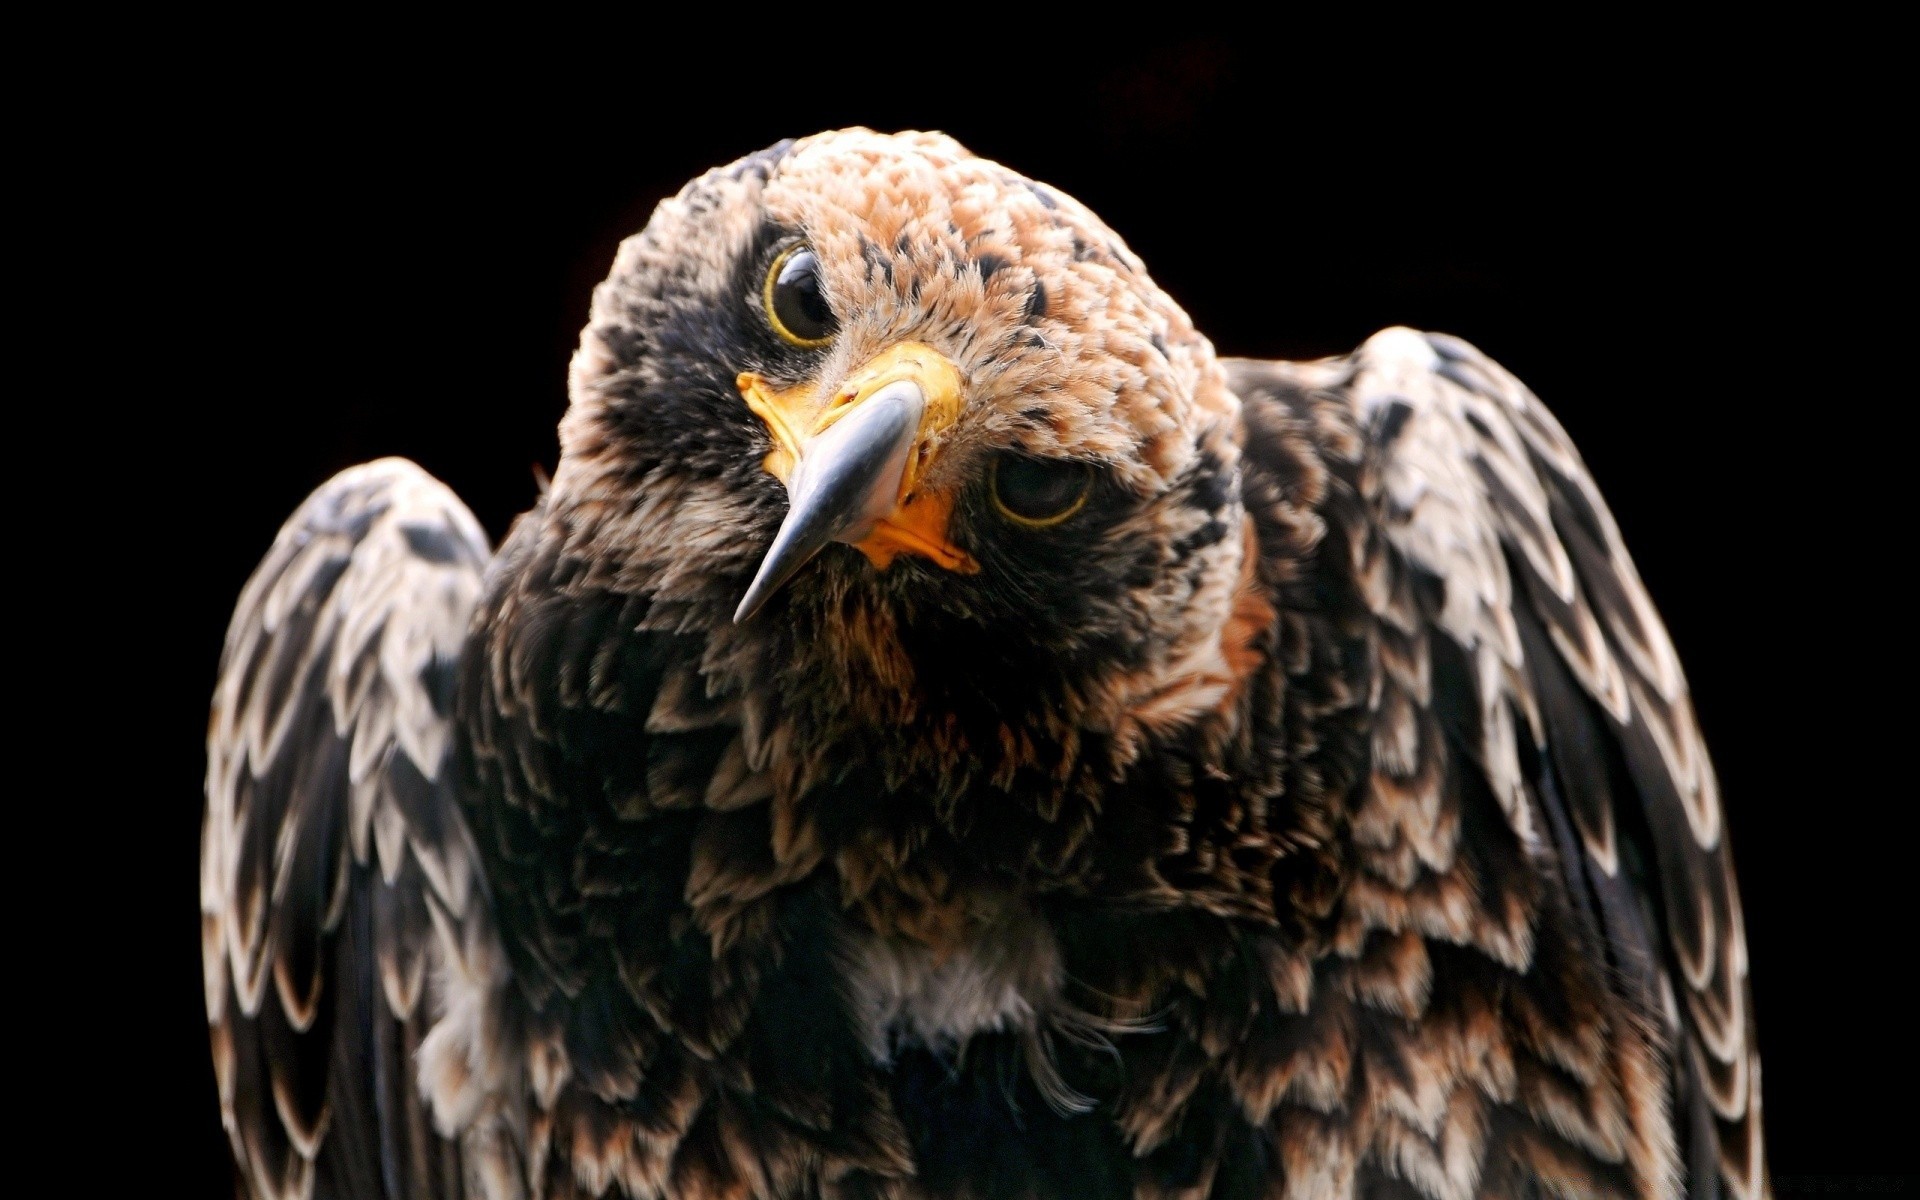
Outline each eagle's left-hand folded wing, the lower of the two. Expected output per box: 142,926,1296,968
200,459,490,1200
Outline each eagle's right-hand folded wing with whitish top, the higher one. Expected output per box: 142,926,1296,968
1229,328,1764,1196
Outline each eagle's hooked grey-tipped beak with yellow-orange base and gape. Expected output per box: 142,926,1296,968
733,342,979,622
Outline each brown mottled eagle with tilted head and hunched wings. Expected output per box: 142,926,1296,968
202,131,1768,1200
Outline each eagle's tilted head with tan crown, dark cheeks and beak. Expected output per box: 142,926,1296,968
549,129,1258,894
